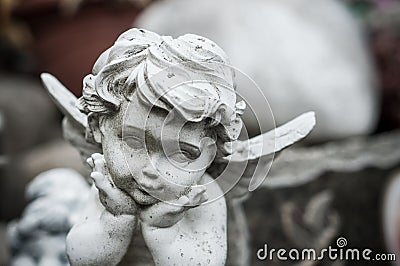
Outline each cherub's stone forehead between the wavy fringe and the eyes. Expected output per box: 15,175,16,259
123,93,206,145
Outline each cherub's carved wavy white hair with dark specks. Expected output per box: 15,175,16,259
77,29,245,156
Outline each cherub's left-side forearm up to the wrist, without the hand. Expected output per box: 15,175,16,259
67,185,137,265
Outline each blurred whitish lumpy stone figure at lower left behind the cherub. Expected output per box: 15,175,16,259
7,168,90,266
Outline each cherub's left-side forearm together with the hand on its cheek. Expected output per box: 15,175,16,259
67,153,138,266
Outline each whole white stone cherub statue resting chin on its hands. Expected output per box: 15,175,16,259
8,29,315,265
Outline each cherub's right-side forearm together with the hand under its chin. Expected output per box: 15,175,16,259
140,177,227,266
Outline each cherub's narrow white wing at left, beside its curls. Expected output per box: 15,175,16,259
40,73,102,164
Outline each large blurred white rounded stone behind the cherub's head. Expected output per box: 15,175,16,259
135,0,379,141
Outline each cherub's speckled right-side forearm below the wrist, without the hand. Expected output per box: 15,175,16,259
142,176,227,265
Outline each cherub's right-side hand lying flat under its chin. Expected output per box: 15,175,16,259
140,185,208,228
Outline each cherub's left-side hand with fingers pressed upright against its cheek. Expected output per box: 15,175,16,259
87,153,137,215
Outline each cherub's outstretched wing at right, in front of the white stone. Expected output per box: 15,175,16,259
209,112,315,199
